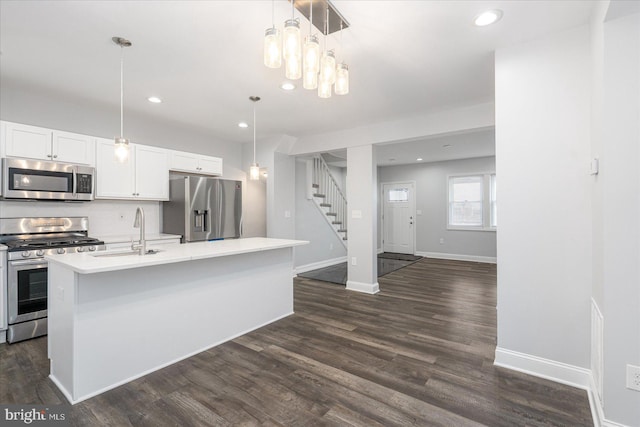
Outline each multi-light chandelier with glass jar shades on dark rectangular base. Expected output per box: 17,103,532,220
264,0,349,98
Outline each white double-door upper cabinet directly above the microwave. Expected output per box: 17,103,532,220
3,122,95,166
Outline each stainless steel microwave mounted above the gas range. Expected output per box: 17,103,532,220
2,158,95,201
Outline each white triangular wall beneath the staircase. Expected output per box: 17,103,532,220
295,161,347,267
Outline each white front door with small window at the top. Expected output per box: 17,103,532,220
382,182,415,255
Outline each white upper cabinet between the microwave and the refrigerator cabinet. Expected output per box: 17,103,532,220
96,138,169,200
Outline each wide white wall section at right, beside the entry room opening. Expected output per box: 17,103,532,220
495,26,592,368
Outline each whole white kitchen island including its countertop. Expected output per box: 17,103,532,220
46,238,308,403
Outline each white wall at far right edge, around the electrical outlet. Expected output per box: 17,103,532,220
601,9,640,426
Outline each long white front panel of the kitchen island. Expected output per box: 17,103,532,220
73,248,293,402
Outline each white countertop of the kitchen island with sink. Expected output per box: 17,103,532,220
45,237,309,274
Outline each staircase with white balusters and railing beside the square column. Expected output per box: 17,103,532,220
307,155,347,248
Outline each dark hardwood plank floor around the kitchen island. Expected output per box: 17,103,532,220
0,258,593,427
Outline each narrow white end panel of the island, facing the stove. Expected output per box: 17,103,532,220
47,263,76,400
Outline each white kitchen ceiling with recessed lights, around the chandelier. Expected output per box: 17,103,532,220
0,0,594,149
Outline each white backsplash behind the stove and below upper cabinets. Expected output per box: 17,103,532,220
0,200,161,237
